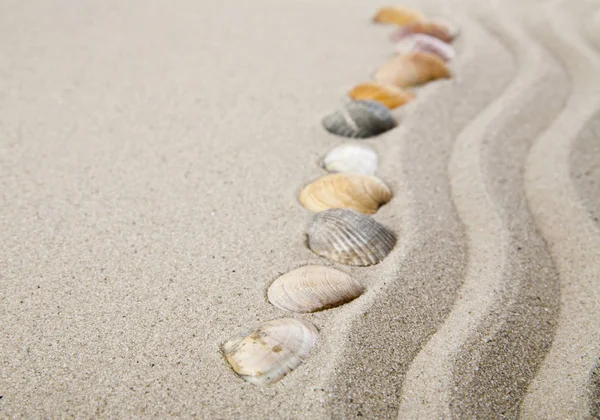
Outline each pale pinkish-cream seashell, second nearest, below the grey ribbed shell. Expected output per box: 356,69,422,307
267,265,364,313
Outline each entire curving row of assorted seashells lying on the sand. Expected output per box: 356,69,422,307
222,7,456,386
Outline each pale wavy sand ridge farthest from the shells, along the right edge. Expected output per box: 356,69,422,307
523,3,600,418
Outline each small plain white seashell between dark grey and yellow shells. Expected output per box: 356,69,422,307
323,143,378,175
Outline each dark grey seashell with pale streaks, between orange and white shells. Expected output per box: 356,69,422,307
322,101,396,139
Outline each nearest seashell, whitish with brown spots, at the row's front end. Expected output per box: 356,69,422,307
223,318,318,386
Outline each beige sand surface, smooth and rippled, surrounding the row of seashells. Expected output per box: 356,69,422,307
0,0,600,419
